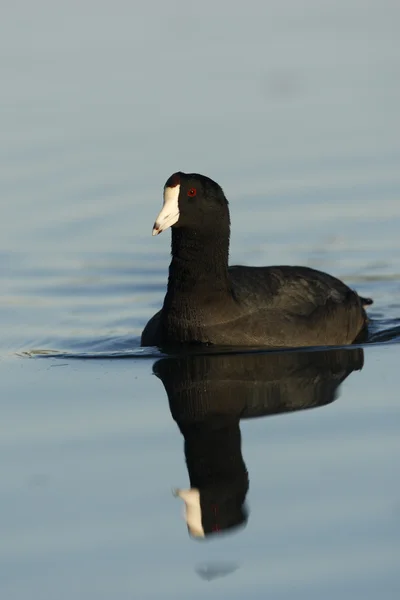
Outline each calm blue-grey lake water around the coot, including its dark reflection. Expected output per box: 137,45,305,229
0,0,400,600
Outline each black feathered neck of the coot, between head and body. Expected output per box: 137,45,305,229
166,224,229,303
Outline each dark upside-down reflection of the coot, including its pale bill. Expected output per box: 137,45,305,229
153,348,364,538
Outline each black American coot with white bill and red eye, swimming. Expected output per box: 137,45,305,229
141,172,372,347
